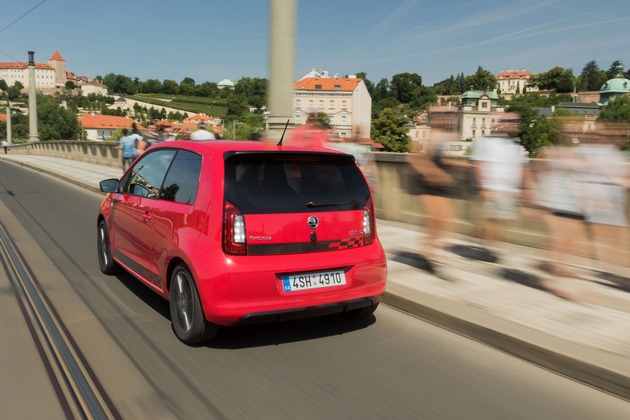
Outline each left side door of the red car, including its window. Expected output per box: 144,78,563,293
111,149,176,285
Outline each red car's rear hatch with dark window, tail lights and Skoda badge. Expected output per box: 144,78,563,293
223,151,374,255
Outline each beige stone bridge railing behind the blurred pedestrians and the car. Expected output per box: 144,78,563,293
11,141,630,266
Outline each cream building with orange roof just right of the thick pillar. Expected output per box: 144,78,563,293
293,72,372,138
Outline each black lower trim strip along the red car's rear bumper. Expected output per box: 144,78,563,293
232,298,379,326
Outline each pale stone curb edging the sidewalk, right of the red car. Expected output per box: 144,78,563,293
382,283,630,401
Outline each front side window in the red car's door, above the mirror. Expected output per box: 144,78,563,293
121,150,176,199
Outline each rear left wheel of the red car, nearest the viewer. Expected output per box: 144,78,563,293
169,264,218,345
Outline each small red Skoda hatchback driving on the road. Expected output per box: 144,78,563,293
97,140,387,344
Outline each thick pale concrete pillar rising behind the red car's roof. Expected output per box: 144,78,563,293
267,0,296,141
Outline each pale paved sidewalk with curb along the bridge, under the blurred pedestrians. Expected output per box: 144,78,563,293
0,154,630,399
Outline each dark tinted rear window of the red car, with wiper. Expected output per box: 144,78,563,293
225,152,370,213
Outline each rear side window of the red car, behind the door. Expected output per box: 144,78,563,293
160,150,201,204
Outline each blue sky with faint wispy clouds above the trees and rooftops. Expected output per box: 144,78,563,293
0,0,630,86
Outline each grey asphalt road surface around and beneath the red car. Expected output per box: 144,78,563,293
0,162,630,419
